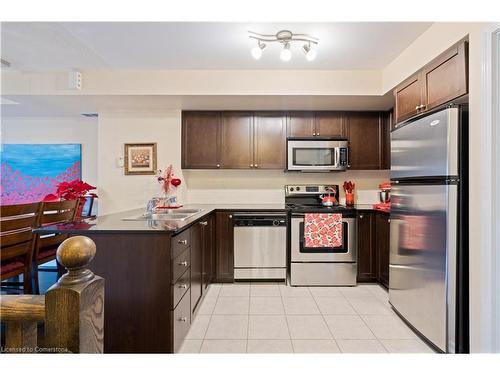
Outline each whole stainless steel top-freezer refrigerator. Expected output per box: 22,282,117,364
389,106,469,353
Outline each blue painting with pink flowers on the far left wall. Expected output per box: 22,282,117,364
0,144,82,205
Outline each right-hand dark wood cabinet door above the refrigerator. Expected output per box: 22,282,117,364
423,42,468,110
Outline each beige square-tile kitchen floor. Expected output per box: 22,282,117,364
181,283,433,353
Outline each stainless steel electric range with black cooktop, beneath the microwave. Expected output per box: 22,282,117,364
285,185,357,286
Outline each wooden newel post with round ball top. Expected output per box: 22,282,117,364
45,236,104,353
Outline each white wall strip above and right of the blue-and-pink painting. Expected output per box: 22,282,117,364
1,117,97,186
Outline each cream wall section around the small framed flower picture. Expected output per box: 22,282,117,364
97,111,185,215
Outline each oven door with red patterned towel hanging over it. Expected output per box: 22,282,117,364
291,217,357,262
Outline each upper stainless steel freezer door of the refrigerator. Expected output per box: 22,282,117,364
391,108,459,179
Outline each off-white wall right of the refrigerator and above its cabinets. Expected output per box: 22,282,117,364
383,23,498,352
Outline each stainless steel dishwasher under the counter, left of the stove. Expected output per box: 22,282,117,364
233,212,287,280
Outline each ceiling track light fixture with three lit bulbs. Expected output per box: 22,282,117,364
248,30,319,61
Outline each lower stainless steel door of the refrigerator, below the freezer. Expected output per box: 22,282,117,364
389,184,457,353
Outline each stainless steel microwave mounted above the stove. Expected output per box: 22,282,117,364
287,137,349,172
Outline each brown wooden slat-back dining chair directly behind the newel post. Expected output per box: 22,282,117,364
33,200,78,294
